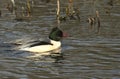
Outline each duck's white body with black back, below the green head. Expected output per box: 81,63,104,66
20,40,61,52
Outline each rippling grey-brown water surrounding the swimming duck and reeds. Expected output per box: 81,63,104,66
0,0,120,79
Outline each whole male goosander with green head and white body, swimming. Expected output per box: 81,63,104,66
20,27,64,53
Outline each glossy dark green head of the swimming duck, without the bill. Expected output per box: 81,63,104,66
49,27,63,41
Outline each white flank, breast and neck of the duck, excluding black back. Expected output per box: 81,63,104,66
20,40,61,52
